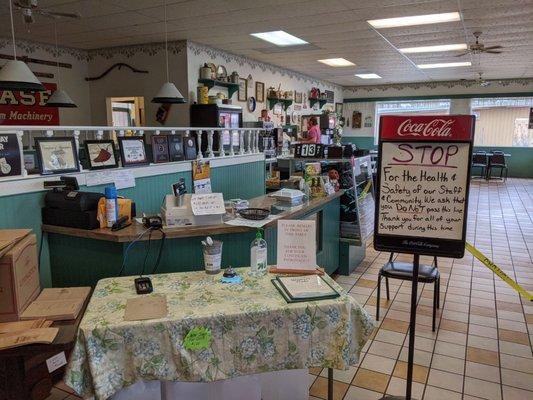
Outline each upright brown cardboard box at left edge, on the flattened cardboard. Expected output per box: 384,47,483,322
0,234,41,322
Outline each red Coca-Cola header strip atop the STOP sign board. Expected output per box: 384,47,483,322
380,115,474,142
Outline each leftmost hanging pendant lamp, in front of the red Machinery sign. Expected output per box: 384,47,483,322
0,0,45,91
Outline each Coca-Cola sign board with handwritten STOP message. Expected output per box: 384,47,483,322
374,115,474,258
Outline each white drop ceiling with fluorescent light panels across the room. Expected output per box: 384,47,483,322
0,0,533,86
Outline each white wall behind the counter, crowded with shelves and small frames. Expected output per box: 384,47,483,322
187,42,343,123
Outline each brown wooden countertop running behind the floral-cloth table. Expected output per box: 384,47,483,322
42,190,343,243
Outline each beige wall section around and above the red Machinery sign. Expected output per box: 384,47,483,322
0,39,91,125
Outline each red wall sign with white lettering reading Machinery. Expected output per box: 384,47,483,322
0,83,60,125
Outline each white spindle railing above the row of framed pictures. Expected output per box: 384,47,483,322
0,126,265,175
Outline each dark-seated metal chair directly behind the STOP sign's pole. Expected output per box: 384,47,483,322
376,253,440,332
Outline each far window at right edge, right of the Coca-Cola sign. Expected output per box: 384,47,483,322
472,97,533,147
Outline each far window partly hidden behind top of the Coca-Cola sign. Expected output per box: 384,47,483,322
374,99,450,144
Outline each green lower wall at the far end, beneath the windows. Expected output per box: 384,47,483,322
342,136,533,178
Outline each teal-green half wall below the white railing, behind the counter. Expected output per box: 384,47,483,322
0,161,265,287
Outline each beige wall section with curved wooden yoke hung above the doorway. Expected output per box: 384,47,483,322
89,41,189,126
